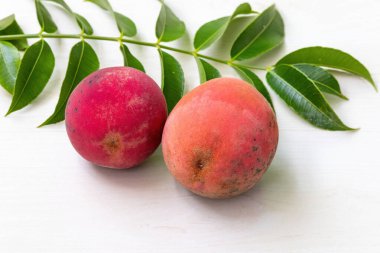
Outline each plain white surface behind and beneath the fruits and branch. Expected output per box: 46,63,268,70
0,0,380,253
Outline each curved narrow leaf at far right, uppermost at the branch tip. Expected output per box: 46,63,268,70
276,47,377,90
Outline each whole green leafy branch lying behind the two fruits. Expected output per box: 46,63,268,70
0,0,377,130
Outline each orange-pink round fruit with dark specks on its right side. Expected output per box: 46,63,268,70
162,78,278,198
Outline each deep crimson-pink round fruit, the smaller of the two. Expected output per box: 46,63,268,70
65,67,167,169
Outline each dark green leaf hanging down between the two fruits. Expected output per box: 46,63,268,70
158,50,185,113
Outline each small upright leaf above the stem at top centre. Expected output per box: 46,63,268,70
156,3,186,42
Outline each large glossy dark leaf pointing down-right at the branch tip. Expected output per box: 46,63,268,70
267,65,354,131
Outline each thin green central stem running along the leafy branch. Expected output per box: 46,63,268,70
0,33,267,71
